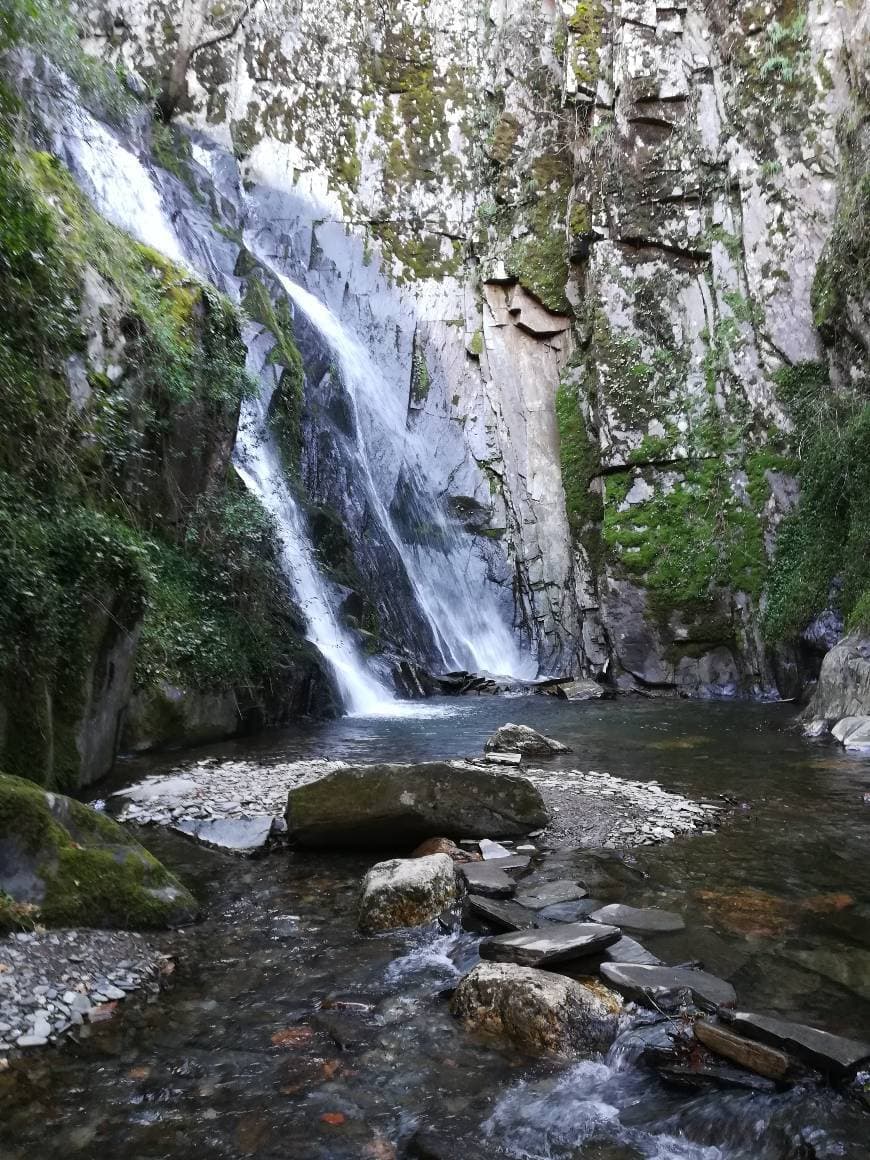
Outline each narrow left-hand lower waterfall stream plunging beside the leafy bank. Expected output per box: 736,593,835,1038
233,335,397,716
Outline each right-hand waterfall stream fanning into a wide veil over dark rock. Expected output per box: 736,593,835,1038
245,235,537,679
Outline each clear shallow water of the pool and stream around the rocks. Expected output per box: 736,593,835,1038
0,697,870,1160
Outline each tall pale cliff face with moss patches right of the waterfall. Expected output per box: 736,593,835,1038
82,0,867,695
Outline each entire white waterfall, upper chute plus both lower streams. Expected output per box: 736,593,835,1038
49,90,535,715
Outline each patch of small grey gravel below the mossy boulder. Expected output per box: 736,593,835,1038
0,930,172,1057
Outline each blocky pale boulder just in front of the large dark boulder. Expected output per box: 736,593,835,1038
358,854,458,934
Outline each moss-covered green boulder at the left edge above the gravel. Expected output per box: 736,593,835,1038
0,774,197,933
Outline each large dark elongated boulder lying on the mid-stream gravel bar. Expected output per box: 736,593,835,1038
287,761,549,849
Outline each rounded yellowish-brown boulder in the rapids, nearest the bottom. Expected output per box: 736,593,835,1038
450,963,622,1057
